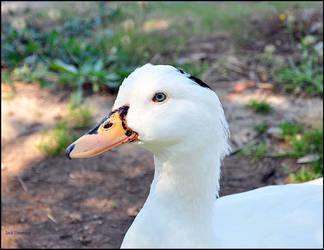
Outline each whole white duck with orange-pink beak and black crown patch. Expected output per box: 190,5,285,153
66,64,323,248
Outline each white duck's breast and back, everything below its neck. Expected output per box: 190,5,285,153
121,150,323,248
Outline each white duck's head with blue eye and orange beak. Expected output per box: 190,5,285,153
66,64,229,158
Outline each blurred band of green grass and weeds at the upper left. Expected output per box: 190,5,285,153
1,2,320,102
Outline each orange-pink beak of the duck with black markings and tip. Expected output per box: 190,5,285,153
65,105,138,159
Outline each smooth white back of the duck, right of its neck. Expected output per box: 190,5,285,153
215,178,323,248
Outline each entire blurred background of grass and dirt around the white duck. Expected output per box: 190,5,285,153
1,1,323,248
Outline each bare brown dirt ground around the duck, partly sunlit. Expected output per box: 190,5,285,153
1,35,323,248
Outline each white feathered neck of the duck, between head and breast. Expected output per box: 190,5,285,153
149,148,220,213
